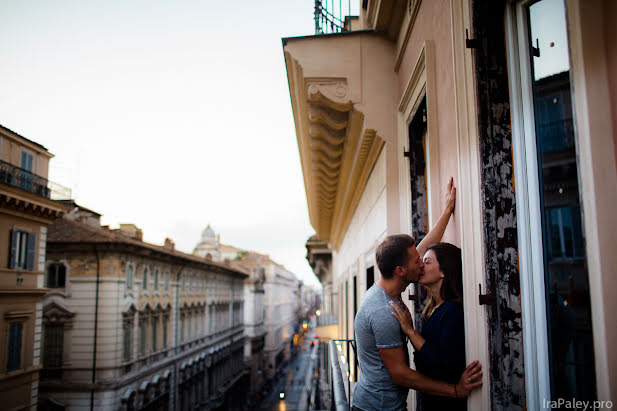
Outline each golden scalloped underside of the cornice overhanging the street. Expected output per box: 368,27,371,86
285,52,384,248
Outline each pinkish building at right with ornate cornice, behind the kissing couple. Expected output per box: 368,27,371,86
283,0,617,410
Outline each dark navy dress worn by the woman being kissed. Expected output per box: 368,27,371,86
414,301,467,411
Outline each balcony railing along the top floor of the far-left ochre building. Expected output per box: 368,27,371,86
0,160,71,200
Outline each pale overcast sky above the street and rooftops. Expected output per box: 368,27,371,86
0,0,328,284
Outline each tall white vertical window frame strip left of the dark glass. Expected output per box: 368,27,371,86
506,0,551,410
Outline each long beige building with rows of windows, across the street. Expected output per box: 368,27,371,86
40,203,249,410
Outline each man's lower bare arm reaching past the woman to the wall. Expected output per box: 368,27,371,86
379,347,482,398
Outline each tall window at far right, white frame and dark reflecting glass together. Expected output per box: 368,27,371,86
507,0,597,408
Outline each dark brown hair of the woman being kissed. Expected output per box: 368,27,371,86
422,243,463,317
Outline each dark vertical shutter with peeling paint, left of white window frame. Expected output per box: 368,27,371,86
470,0,525,410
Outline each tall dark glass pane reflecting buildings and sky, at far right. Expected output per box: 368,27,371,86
529,0,596,400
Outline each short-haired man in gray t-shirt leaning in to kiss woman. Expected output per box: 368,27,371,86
353,178,482,411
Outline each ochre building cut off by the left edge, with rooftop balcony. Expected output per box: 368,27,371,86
0,126,67,410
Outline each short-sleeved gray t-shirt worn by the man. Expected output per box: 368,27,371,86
353,284,409,411
